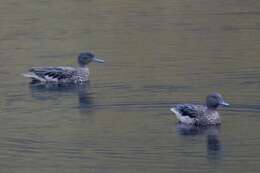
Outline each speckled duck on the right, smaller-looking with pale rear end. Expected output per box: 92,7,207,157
170,93,229,126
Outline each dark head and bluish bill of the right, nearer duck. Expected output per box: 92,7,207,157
206,93,229,109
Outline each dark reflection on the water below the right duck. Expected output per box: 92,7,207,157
176,123,221,159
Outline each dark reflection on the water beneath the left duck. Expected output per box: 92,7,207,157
29,82,94,109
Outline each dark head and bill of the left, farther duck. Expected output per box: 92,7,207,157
78,52,104,67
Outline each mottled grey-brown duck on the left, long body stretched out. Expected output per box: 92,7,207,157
22,51,104,83
